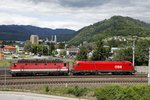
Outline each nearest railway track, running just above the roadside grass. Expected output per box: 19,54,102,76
0,78,148,86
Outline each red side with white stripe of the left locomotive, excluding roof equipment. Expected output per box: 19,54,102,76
11,63,68,75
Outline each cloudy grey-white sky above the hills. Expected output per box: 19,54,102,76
0,0,150,30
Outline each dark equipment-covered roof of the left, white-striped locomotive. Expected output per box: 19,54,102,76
18,59,63,63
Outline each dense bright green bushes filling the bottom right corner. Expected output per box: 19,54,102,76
95,85,150,100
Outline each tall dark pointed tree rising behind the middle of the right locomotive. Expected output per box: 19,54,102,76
91,39,110,61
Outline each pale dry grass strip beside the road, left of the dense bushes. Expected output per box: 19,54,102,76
0,85,95,100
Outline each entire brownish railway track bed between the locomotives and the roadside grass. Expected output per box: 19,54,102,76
0,75,148,87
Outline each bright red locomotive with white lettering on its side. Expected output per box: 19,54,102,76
72,61,135,75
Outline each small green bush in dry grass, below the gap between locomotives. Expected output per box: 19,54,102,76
67,86,87,97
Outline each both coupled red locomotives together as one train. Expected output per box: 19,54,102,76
10,59,135,76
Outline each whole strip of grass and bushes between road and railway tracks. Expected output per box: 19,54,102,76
0,84,150,100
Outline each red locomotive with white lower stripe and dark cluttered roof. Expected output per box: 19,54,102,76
10,59,69,76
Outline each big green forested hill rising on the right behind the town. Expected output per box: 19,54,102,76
69,16,150,45
